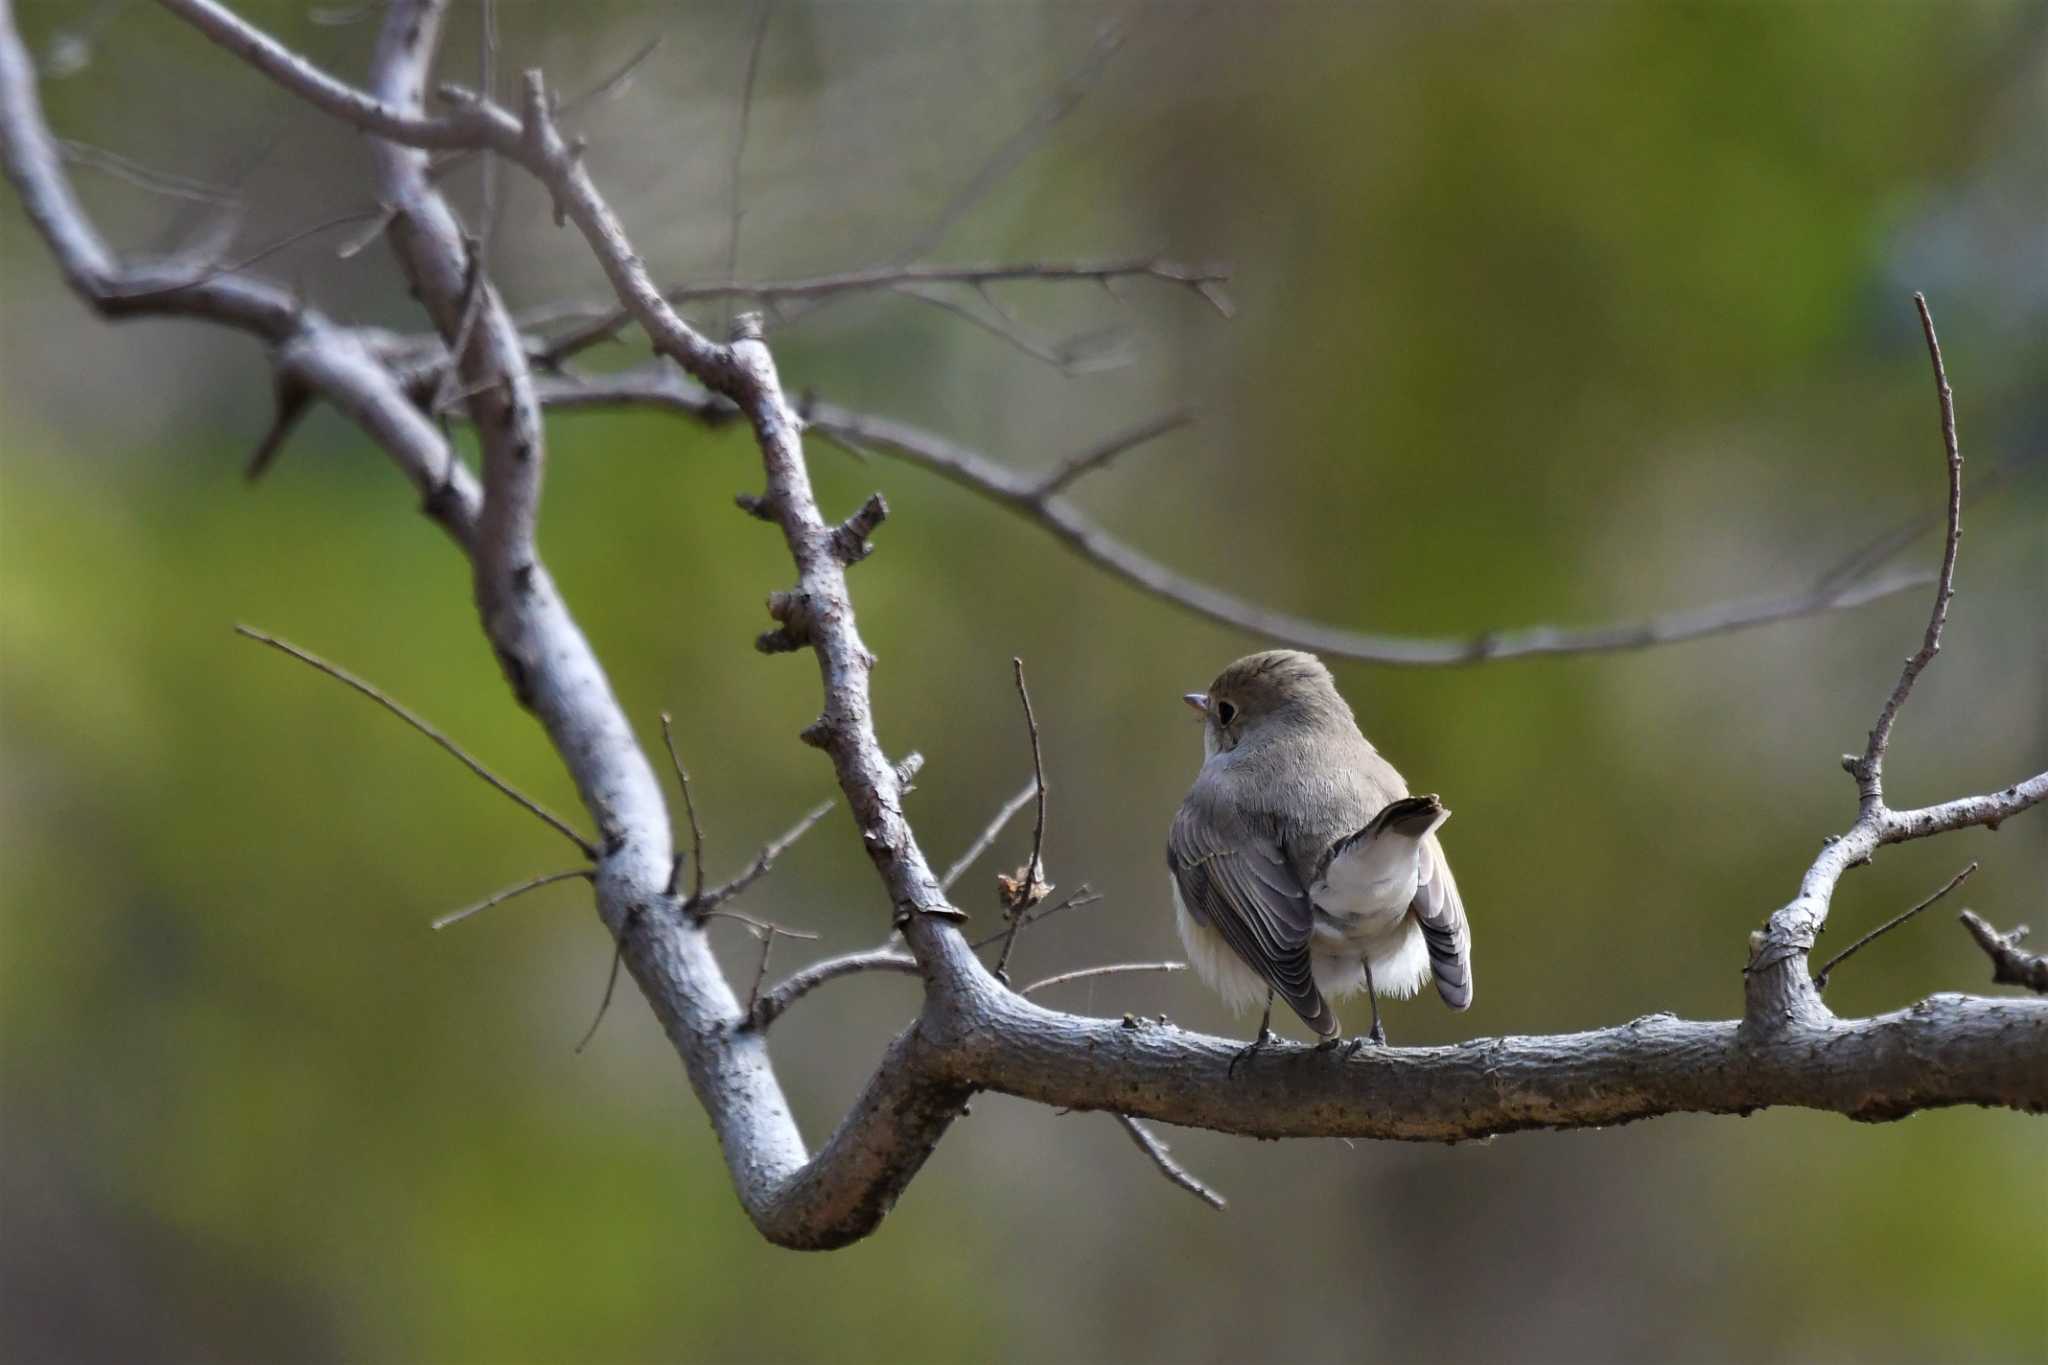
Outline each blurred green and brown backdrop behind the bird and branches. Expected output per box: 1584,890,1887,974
0,0,2048,1361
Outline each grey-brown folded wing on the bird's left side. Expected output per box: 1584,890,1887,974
1165,796,1337,1038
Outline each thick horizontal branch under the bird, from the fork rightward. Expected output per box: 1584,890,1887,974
934,990,2048,1142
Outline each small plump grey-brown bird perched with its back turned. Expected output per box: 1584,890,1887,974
1165,649,1473,1052
